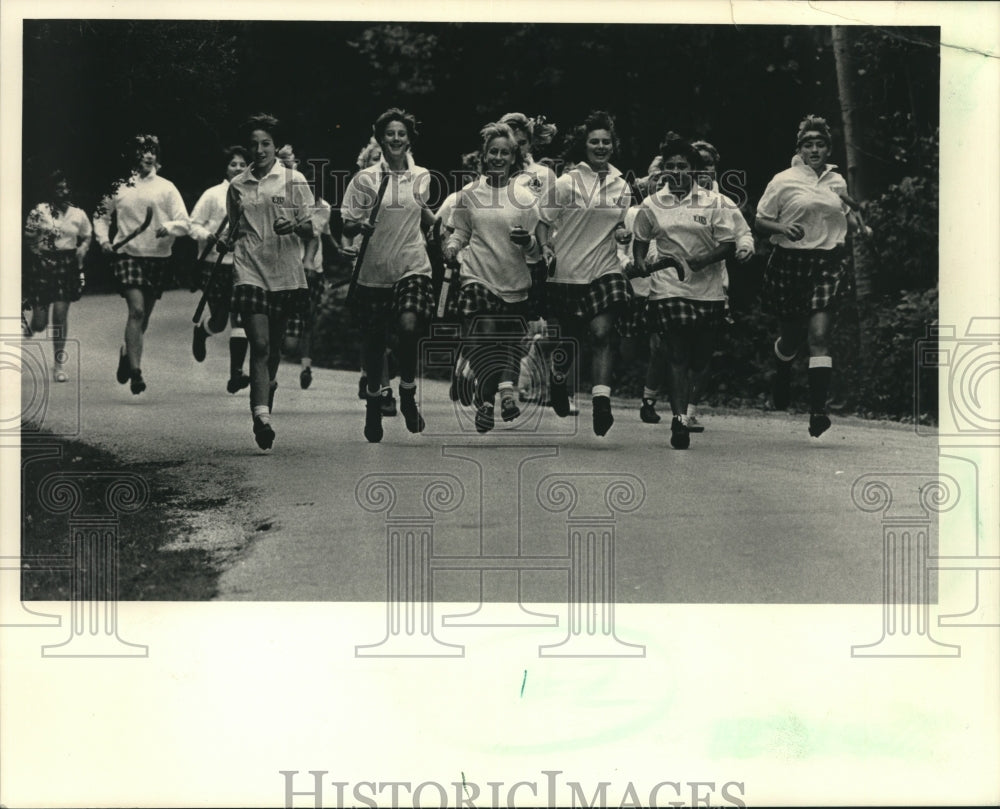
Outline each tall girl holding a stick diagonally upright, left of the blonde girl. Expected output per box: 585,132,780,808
341,107,435,443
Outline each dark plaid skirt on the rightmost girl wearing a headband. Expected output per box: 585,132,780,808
761,247,850,320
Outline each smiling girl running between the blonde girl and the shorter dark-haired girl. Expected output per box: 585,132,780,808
536,111,632,436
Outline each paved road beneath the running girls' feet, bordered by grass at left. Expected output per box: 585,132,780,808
25,291,937,603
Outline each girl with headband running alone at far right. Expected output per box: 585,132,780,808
755,115,864,438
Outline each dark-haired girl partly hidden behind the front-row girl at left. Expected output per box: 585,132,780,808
191,145,250,393
